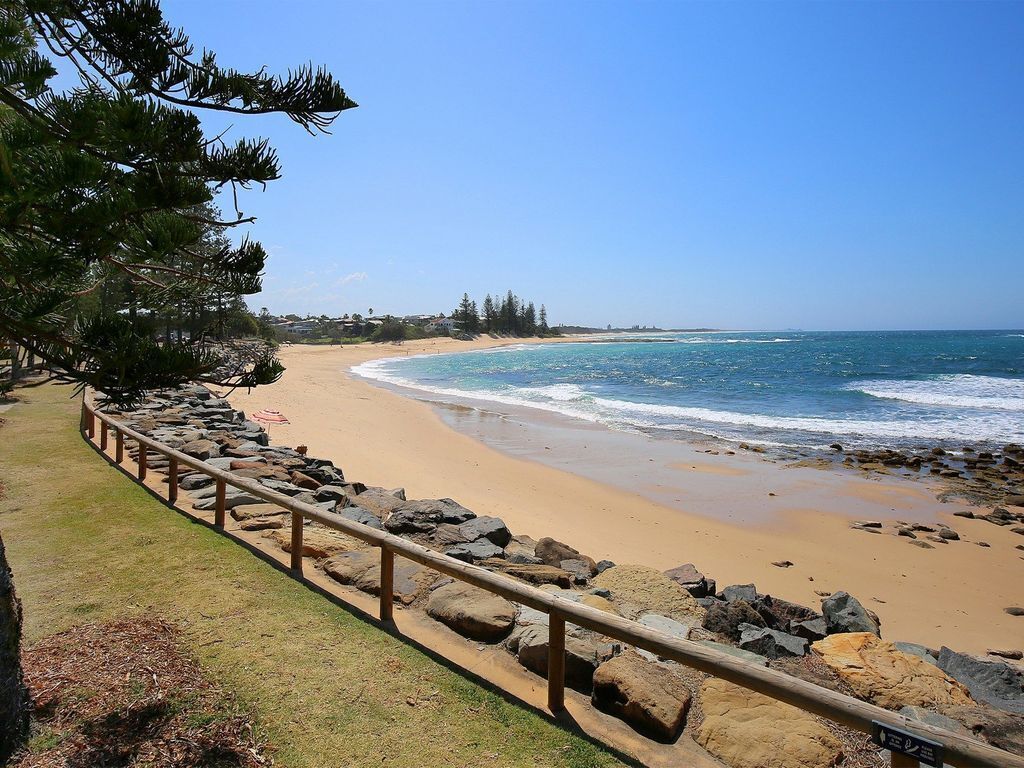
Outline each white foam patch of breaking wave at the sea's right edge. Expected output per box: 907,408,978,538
847,374,1024,411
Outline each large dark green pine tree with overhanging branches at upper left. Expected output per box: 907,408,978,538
0,0,356,403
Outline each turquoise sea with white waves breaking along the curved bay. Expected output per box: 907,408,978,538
353,331,1024,447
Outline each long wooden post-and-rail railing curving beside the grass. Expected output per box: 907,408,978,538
82,397,1024,768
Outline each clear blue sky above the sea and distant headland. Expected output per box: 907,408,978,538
164,0,1024,329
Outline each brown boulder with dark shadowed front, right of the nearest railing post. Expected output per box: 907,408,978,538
591,652,690,741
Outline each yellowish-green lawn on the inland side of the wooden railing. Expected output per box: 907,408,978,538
0,385,621,768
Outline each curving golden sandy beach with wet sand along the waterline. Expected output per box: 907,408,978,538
230,338,1024,652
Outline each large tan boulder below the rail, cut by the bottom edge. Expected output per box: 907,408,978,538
695,678,843,768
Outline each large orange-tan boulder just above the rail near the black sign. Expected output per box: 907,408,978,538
811,632,971,710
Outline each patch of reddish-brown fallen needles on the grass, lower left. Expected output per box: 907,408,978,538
12,616,273,768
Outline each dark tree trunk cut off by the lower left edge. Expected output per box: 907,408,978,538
0,538,29,764
